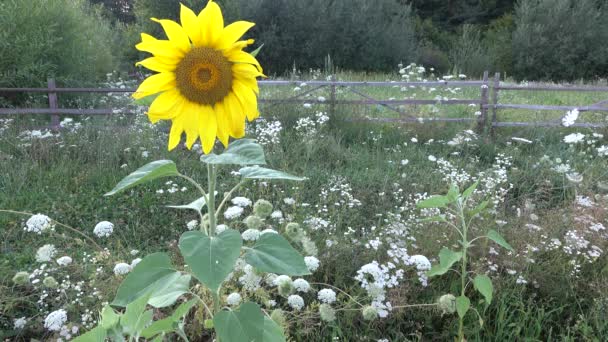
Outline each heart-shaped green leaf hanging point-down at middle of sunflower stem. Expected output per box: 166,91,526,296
179,229,243,292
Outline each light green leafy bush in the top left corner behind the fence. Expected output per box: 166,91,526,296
0,0,114,87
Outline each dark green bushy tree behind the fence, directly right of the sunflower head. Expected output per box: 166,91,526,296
240,0,417,73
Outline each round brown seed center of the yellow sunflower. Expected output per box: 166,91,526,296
175,47,232,105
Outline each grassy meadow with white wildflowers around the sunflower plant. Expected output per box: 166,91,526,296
0,69,608,341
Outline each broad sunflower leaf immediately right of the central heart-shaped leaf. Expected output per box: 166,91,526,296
245,234,310,276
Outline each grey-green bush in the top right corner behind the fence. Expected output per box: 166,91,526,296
512,0,608,80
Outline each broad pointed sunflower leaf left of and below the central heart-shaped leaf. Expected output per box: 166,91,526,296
112,253,182,306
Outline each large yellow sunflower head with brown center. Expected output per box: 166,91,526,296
133,0,264,153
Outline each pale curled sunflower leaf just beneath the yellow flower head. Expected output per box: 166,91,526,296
201,139,266,165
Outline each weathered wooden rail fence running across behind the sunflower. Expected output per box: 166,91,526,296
0,72,608,134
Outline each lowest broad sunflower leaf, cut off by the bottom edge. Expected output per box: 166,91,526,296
213,302,264,342
